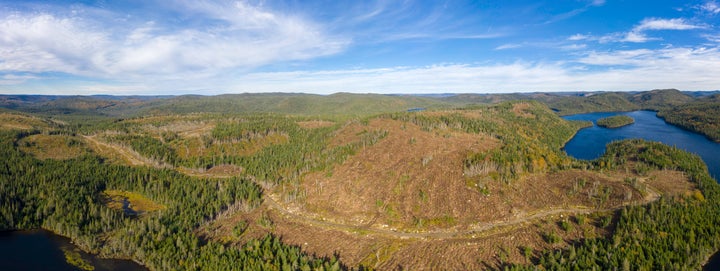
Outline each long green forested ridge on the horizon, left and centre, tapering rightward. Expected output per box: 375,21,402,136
0,93,451,117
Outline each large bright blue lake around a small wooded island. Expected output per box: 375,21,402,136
564,111,720,183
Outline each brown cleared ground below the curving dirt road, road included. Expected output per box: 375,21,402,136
199,168,689,270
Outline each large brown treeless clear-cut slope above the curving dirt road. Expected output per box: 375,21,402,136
302,119,498,231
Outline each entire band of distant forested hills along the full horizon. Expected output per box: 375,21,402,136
0,89,720,120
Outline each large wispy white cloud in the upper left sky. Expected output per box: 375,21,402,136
0,1,348,78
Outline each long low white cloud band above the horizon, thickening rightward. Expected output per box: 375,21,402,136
3,47,720,94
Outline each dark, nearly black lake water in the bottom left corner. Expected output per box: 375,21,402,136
0,230,147,271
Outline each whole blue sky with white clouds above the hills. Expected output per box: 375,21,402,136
0,0,720,95
